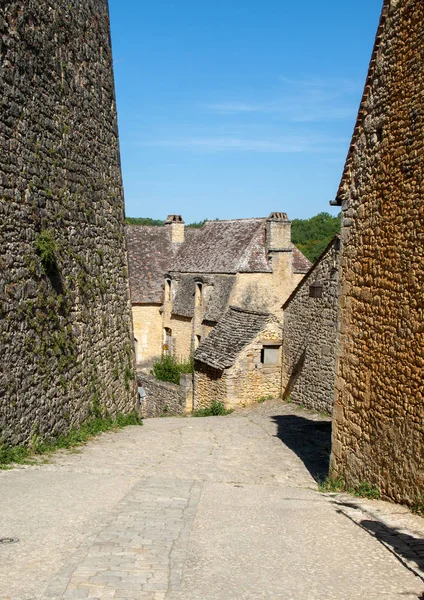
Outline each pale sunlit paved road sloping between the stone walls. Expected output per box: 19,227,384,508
0,402,424,600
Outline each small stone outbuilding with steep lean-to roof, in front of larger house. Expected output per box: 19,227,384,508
194,306,282,408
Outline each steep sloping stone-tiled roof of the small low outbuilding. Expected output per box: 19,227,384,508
194,306,276,370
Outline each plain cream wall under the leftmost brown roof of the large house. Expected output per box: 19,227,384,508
132,304,163,365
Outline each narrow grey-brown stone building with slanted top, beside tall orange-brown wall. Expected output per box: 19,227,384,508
282,236,340,413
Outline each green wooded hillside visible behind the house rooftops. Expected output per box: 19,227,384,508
126,212,340,262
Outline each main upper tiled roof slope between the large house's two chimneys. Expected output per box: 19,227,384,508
171,219,271,273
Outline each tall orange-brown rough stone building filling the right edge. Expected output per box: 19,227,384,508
331,0,424,505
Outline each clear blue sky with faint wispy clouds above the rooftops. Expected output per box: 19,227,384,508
109,0,382,222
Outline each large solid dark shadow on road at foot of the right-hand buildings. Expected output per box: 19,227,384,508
271,415,331,481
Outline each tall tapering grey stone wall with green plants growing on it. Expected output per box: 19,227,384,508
0,0,136,444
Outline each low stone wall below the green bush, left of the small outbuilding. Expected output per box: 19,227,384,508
137,372,193,418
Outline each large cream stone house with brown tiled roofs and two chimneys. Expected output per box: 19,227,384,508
127,213,310,364
